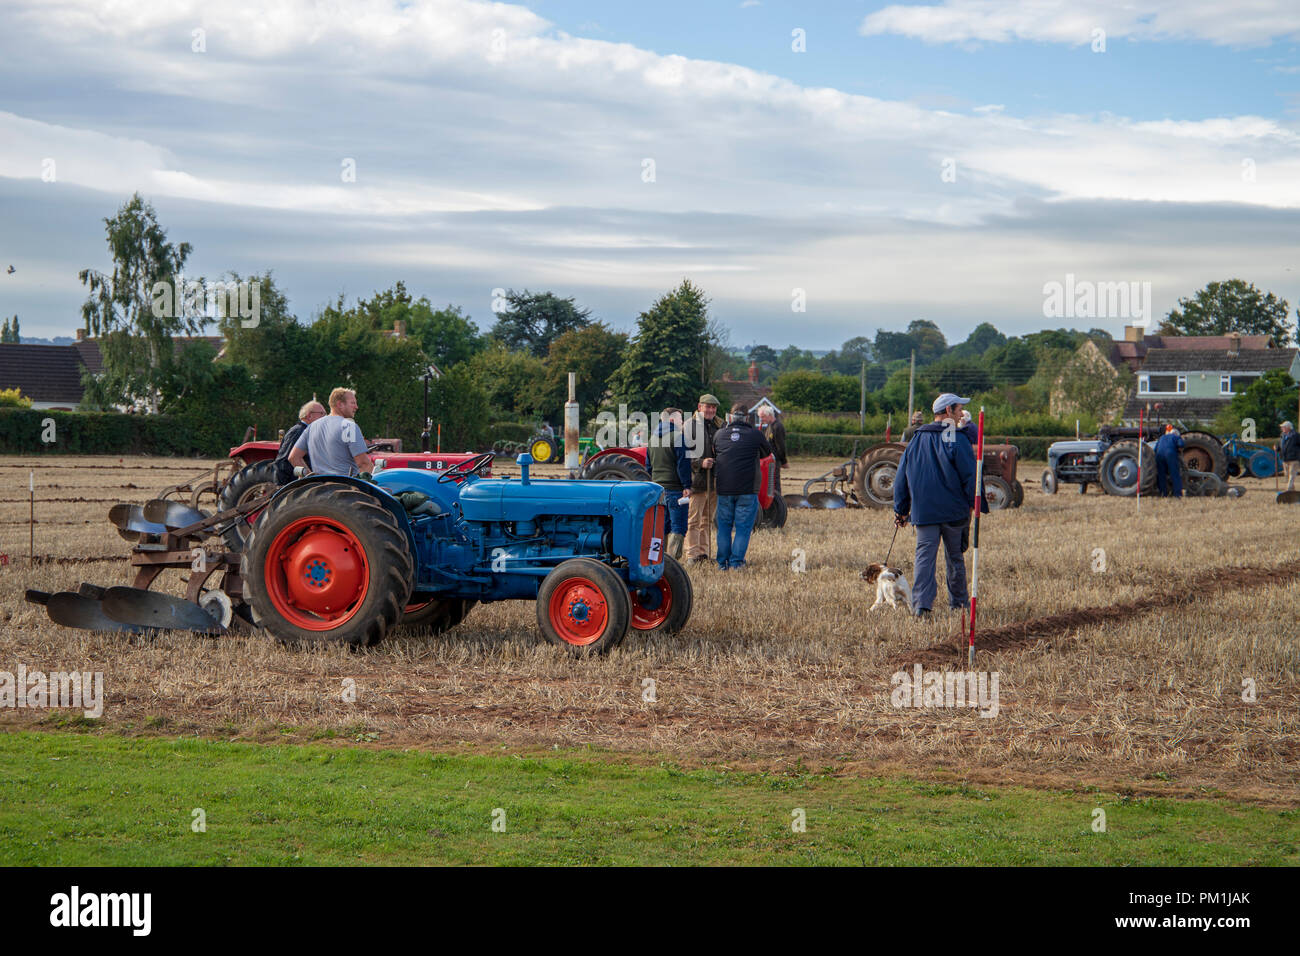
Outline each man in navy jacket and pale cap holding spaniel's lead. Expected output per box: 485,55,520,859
894,392,975,618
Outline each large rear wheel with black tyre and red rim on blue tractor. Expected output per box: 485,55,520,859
243,481,415,646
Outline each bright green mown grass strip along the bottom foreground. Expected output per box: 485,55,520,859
0,732,1300,865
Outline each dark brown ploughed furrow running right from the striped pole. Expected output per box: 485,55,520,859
889,561,1300,666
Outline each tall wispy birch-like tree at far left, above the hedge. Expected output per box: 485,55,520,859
78,193,198,411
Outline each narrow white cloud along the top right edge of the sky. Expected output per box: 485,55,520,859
861,0,1300,46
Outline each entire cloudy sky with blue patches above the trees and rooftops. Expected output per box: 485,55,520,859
0,0,1300,349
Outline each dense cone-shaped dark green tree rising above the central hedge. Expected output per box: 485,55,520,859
610,278,718,414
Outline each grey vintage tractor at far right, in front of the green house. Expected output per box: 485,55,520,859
1043,423,1229,498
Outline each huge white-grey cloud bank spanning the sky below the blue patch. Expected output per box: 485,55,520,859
0,0,1300,345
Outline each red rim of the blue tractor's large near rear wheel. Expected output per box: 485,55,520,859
264,518,371,631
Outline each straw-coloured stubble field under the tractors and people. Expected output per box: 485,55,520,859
0,457,1300,806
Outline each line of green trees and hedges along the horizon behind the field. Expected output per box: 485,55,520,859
35,194,1292,450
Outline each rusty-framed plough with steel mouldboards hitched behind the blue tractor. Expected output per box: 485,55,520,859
26,494,270,633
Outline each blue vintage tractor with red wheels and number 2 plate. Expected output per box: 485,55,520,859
241,454,692,654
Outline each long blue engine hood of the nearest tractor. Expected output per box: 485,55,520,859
460,479,663,524
